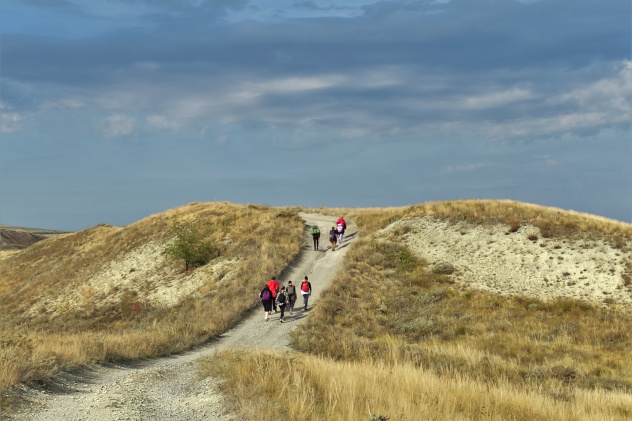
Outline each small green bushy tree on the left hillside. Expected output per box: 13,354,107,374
163,223,217,271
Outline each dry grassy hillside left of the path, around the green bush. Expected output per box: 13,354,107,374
0,203,304,396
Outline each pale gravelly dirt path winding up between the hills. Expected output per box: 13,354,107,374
11,213,357,421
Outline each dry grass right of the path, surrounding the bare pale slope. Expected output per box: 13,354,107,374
202,201,632,420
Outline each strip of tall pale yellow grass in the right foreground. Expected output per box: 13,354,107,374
201,350,632,421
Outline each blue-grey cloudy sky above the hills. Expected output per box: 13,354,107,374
0,0,632,231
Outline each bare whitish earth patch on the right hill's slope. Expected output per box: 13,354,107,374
380,216,632,306
